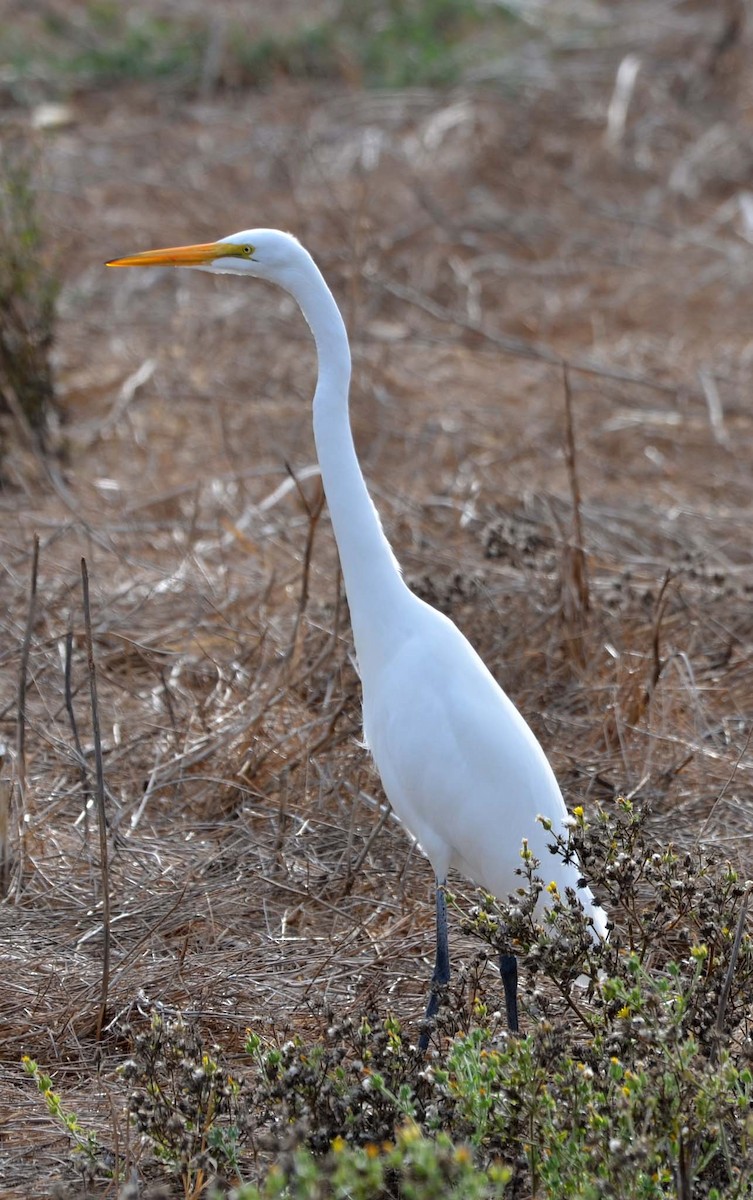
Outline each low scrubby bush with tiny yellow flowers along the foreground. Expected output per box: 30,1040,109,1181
28,800,753,1200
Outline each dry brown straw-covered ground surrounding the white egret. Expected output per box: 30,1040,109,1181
0,2,753,1196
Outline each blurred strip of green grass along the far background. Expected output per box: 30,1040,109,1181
0,0,519,97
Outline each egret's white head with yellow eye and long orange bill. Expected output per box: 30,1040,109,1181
107,229,308,289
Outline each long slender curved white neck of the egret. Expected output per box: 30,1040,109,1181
285,254,414,677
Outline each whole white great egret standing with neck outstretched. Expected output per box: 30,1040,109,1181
108,229,606,1048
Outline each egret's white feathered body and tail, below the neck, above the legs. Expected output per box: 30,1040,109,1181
363,601,603,928
